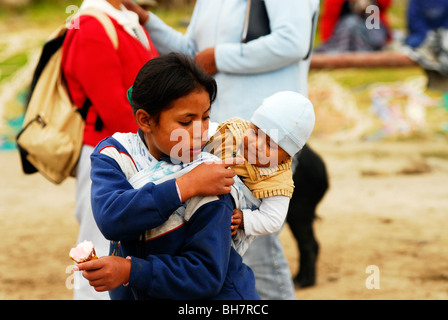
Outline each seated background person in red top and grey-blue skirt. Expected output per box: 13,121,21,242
316,0,392,52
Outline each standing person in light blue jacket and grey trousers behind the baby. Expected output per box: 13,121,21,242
124,0,319,300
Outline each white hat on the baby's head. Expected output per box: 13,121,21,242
250,91,315,157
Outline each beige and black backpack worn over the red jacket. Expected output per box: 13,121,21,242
16,9,118,184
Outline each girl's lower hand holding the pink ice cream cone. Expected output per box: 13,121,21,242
73,256,131,292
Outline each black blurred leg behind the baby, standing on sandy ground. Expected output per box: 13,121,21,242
286,145,329,287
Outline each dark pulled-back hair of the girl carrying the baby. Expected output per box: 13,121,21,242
131,52,217,122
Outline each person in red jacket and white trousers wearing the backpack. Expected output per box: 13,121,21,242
62,0,159,299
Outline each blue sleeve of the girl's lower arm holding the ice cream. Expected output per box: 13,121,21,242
125,195,232,299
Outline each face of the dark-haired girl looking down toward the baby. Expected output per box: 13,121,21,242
136,90,210,163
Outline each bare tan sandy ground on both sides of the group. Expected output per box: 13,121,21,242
0,139,448,300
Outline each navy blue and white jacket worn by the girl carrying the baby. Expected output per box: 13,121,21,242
91,134,259,300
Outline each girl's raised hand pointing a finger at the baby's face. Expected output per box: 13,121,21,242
176,158,244,202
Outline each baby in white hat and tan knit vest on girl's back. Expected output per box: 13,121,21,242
204,91,315,236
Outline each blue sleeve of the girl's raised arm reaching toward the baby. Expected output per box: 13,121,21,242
91,145,182,241
